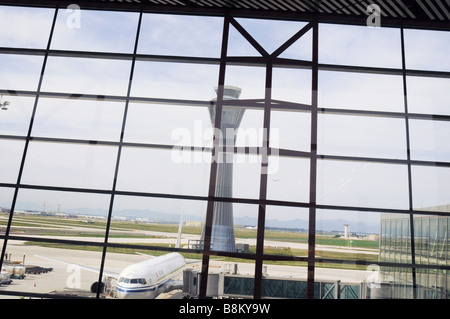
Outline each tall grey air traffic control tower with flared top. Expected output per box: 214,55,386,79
201,86,245,252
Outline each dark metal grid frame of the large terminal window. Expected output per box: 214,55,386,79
0,3,450,299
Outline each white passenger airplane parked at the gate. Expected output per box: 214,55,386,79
35,214,199,299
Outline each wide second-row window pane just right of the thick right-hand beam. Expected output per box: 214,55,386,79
319,71,405,112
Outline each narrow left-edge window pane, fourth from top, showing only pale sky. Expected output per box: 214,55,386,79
0,139,25,183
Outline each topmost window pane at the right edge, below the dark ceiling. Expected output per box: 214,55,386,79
405,29,450,71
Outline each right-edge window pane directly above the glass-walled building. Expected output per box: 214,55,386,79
412,165,450,212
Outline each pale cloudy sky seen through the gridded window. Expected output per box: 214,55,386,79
0,3,450,231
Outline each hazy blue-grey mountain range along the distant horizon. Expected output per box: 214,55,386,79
5,202,380,234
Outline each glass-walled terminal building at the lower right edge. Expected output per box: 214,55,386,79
380,210,450,299
